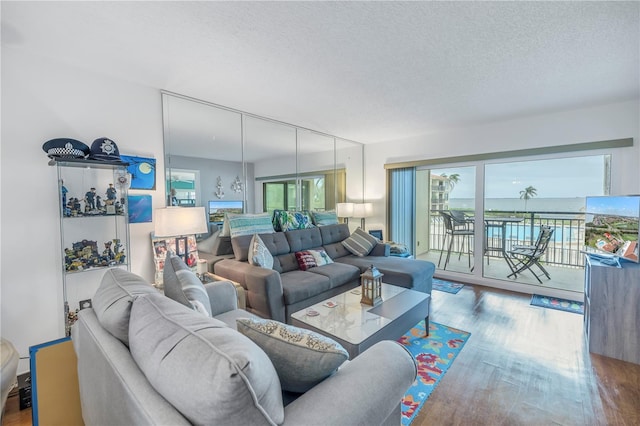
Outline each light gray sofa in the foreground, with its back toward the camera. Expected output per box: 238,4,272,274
72,266,417,425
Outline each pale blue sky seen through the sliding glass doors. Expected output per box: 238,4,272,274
431,155,605,198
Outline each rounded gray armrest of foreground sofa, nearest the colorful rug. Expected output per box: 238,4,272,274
284,340,417,425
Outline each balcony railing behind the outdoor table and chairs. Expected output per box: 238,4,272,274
429,210,585,267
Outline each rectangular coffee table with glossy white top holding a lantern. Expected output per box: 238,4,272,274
291,284,430,359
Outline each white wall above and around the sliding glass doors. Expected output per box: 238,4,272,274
365,100,640,235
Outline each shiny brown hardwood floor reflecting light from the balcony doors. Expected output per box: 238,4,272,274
3,285,640,426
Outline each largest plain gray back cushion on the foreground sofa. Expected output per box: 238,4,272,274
130,295,284,424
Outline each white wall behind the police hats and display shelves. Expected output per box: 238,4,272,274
0,46,164,372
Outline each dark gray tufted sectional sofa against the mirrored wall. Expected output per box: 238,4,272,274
213,224,435,323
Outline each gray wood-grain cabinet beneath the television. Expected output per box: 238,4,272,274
584,256,640,364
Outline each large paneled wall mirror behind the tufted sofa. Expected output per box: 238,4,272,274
162,92,364,226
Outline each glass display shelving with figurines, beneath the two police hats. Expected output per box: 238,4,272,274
50,159,130,336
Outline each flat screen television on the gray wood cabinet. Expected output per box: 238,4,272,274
584,195,640,263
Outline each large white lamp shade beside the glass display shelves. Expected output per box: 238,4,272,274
154,207,209,238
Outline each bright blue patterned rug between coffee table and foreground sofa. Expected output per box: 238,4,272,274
398,321,471,426
